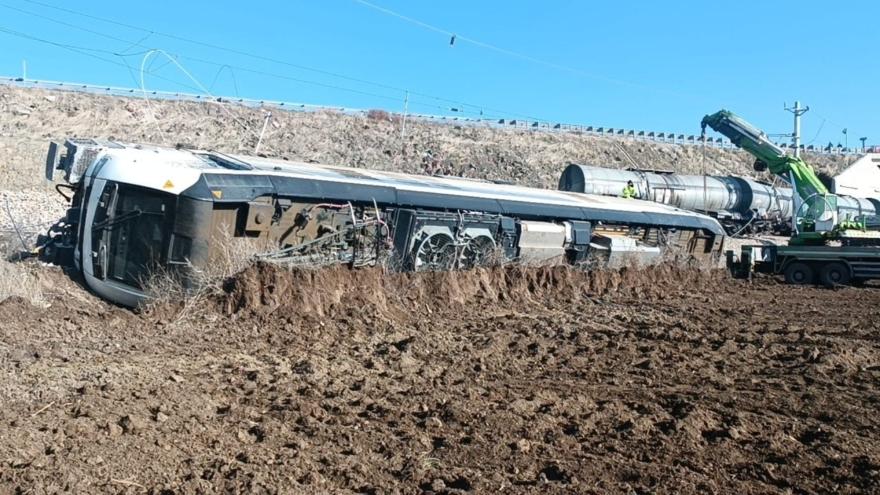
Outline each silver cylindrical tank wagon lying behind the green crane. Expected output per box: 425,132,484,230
559,164,880,234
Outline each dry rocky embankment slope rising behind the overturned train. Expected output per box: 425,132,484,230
0,86,845,242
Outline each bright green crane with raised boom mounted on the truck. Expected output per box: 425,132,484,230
701,110,874,245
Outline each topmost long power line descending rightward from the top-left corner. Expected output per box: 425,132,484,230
19,0,548,122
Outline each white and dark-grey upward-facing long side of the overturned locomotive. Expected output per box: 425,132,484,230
89,145,723,235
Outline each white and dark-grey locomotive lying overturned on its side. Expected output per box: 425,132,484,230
46,140,724,306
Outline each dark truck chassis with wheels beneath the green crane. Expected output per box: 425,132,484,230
727,245,880,287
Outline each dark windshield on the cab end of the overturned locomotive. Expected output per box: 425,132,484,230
104,184,174,287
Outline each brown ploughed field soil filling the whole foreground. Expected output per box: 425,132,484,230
0,265,880,494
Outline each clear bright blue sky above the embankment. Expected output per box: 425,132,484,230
0,0,880,146
